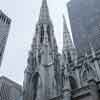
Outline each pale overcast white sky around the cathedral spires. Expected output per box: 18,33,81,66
0,0,69,84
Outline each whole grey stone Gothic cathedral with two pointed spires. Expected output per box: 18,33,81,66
23,0,100,100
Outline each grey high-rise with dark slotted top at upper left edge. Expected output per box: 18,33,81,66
0,10,11,65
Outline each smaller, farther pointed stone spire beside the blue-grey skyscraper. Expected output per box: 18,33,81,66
63,15,74,50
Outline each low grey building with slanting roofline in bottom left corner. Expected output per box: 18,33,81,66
0,76,22,100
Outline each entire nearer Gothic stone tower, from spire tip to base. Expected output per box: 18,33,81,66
24,0,61,100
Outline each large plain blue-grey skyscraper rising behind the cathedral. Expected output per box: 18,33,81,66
67,0,100,55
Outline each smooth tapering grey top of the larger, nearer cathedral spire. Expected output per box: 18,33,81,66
39,0,50,23
